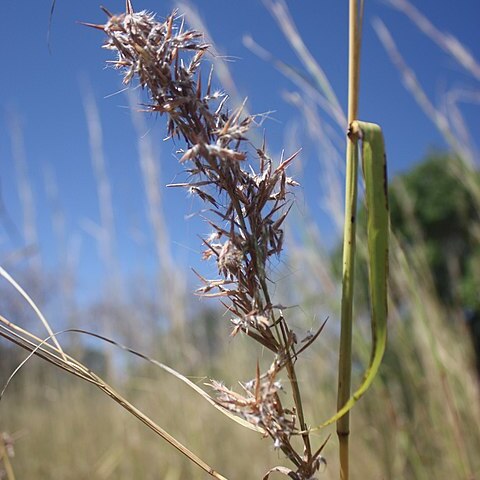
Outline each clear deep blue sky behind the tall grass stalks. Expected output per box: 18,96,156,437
0,0,480,304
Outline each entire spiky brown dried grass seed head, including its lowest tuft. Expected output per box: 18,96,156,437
90,1,321,479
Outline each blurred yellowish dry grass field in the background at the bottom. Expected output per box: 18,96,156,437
1,270,480,479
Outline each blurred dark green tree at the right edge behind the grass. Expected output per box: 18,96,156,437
390,153,480,311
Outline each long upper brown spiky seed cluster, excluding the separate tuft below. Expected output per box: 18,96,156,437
101,1,297,352
